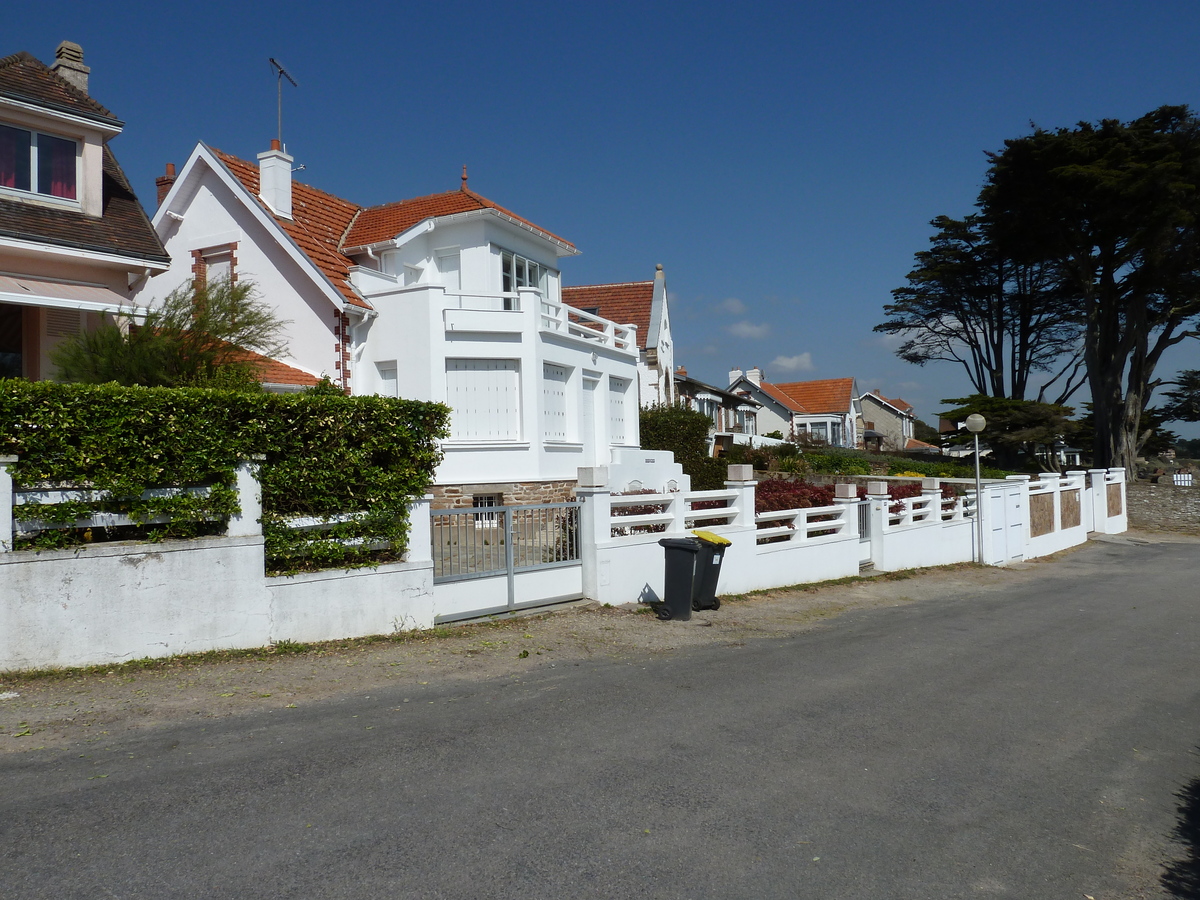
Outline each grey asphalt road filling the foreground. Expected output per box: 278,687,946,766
0,544,1200,900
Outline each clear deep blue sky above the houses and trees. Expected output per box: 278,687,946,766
0,0,1200,437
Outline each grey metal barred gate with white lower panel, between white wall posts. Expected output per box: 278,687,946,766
430,503,583,622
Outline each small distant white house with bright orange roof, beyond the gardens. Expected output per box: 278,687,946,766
727,367,860,448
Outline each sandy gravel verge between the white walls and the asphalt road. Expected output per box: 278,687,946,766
0,484,1200,752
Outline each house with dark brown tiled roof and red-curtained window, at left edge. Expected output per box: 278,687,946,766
0,41,170,380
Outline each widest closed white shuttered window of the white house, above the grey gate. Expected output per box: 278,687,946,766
446,359,521,440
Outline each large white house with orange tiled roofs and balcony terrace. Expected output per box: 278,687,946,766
140,140,638,506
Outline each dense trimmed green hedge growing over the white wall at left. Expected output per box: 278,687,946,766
0,379,449,571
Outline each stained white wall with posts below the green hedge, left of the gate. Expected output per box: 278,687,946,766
0,458,437,671
